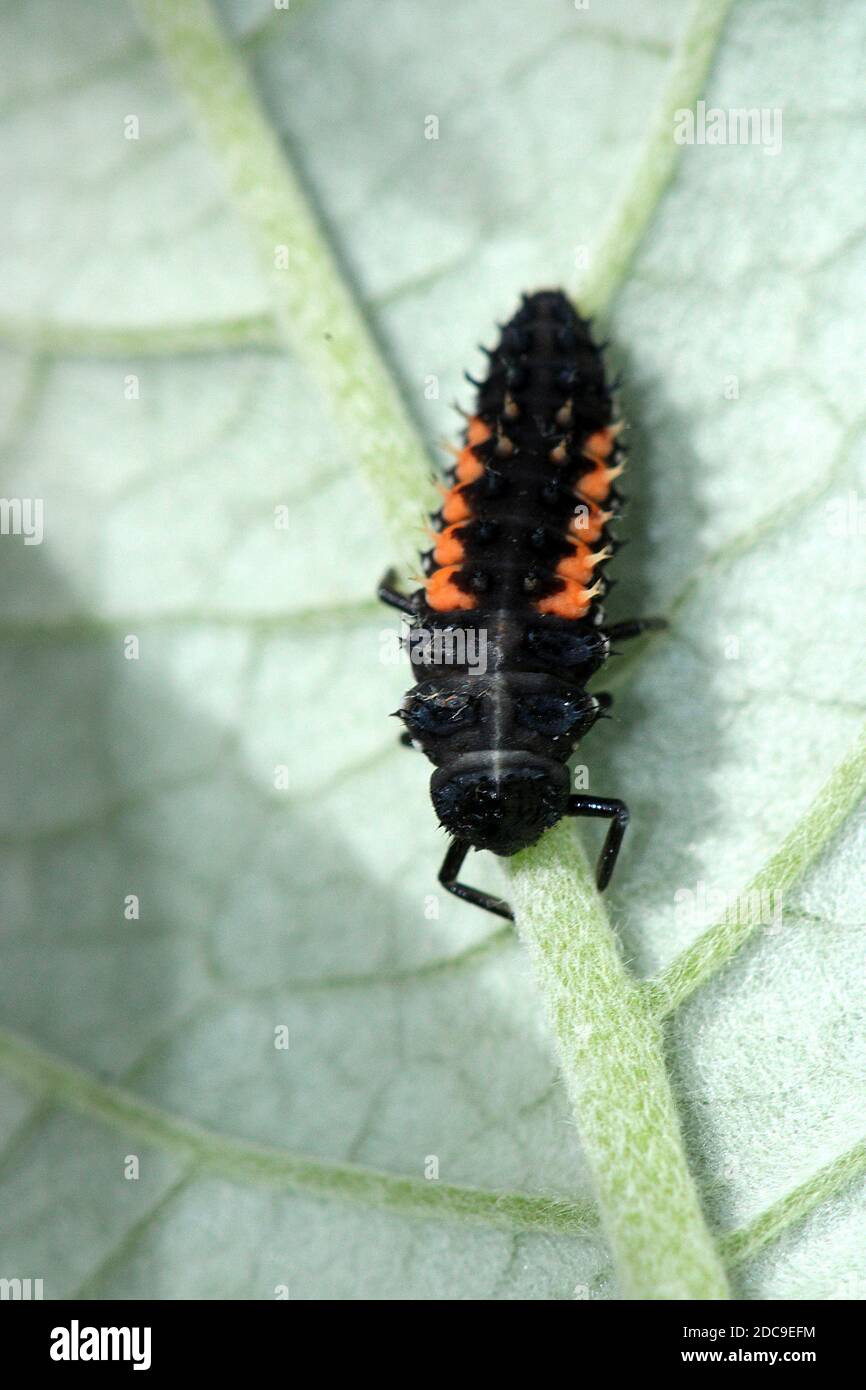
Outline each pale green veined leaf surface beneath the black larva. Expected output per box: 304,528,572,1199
0,0,866,1298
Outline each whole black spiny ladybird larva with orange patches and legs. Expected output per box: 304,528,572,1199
379,291,664,917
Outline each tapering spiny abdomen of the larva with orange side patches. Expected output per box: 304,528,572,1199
425,291,623,623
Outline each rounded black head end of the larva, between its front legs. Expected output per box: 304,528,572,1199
430,752,569,855
